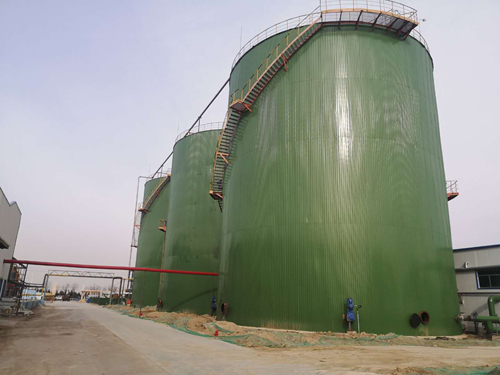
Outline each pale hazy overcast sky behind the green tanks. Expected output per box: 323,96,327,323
0,0,500,290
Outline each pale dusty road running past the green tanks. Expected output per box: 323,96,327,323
0,302,500,375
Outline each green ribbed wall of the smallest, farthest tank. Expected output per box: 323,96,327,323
132,178,170,306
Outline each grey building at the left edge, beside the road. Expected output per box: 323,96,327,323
0,188,21,298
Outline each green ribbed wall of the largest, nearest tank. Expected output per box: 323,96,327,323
220,26,460,335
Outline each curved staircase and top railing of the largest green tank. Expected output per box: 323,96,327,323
210,0,428,210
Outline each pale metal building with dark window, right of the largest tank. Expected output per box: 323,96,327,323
453,244,500,332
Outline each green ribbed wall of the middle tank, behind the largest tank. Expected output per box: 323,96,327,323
160,130,222,314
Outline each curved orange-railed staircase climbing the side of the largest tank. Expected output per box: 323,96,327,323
210,10,322,211
